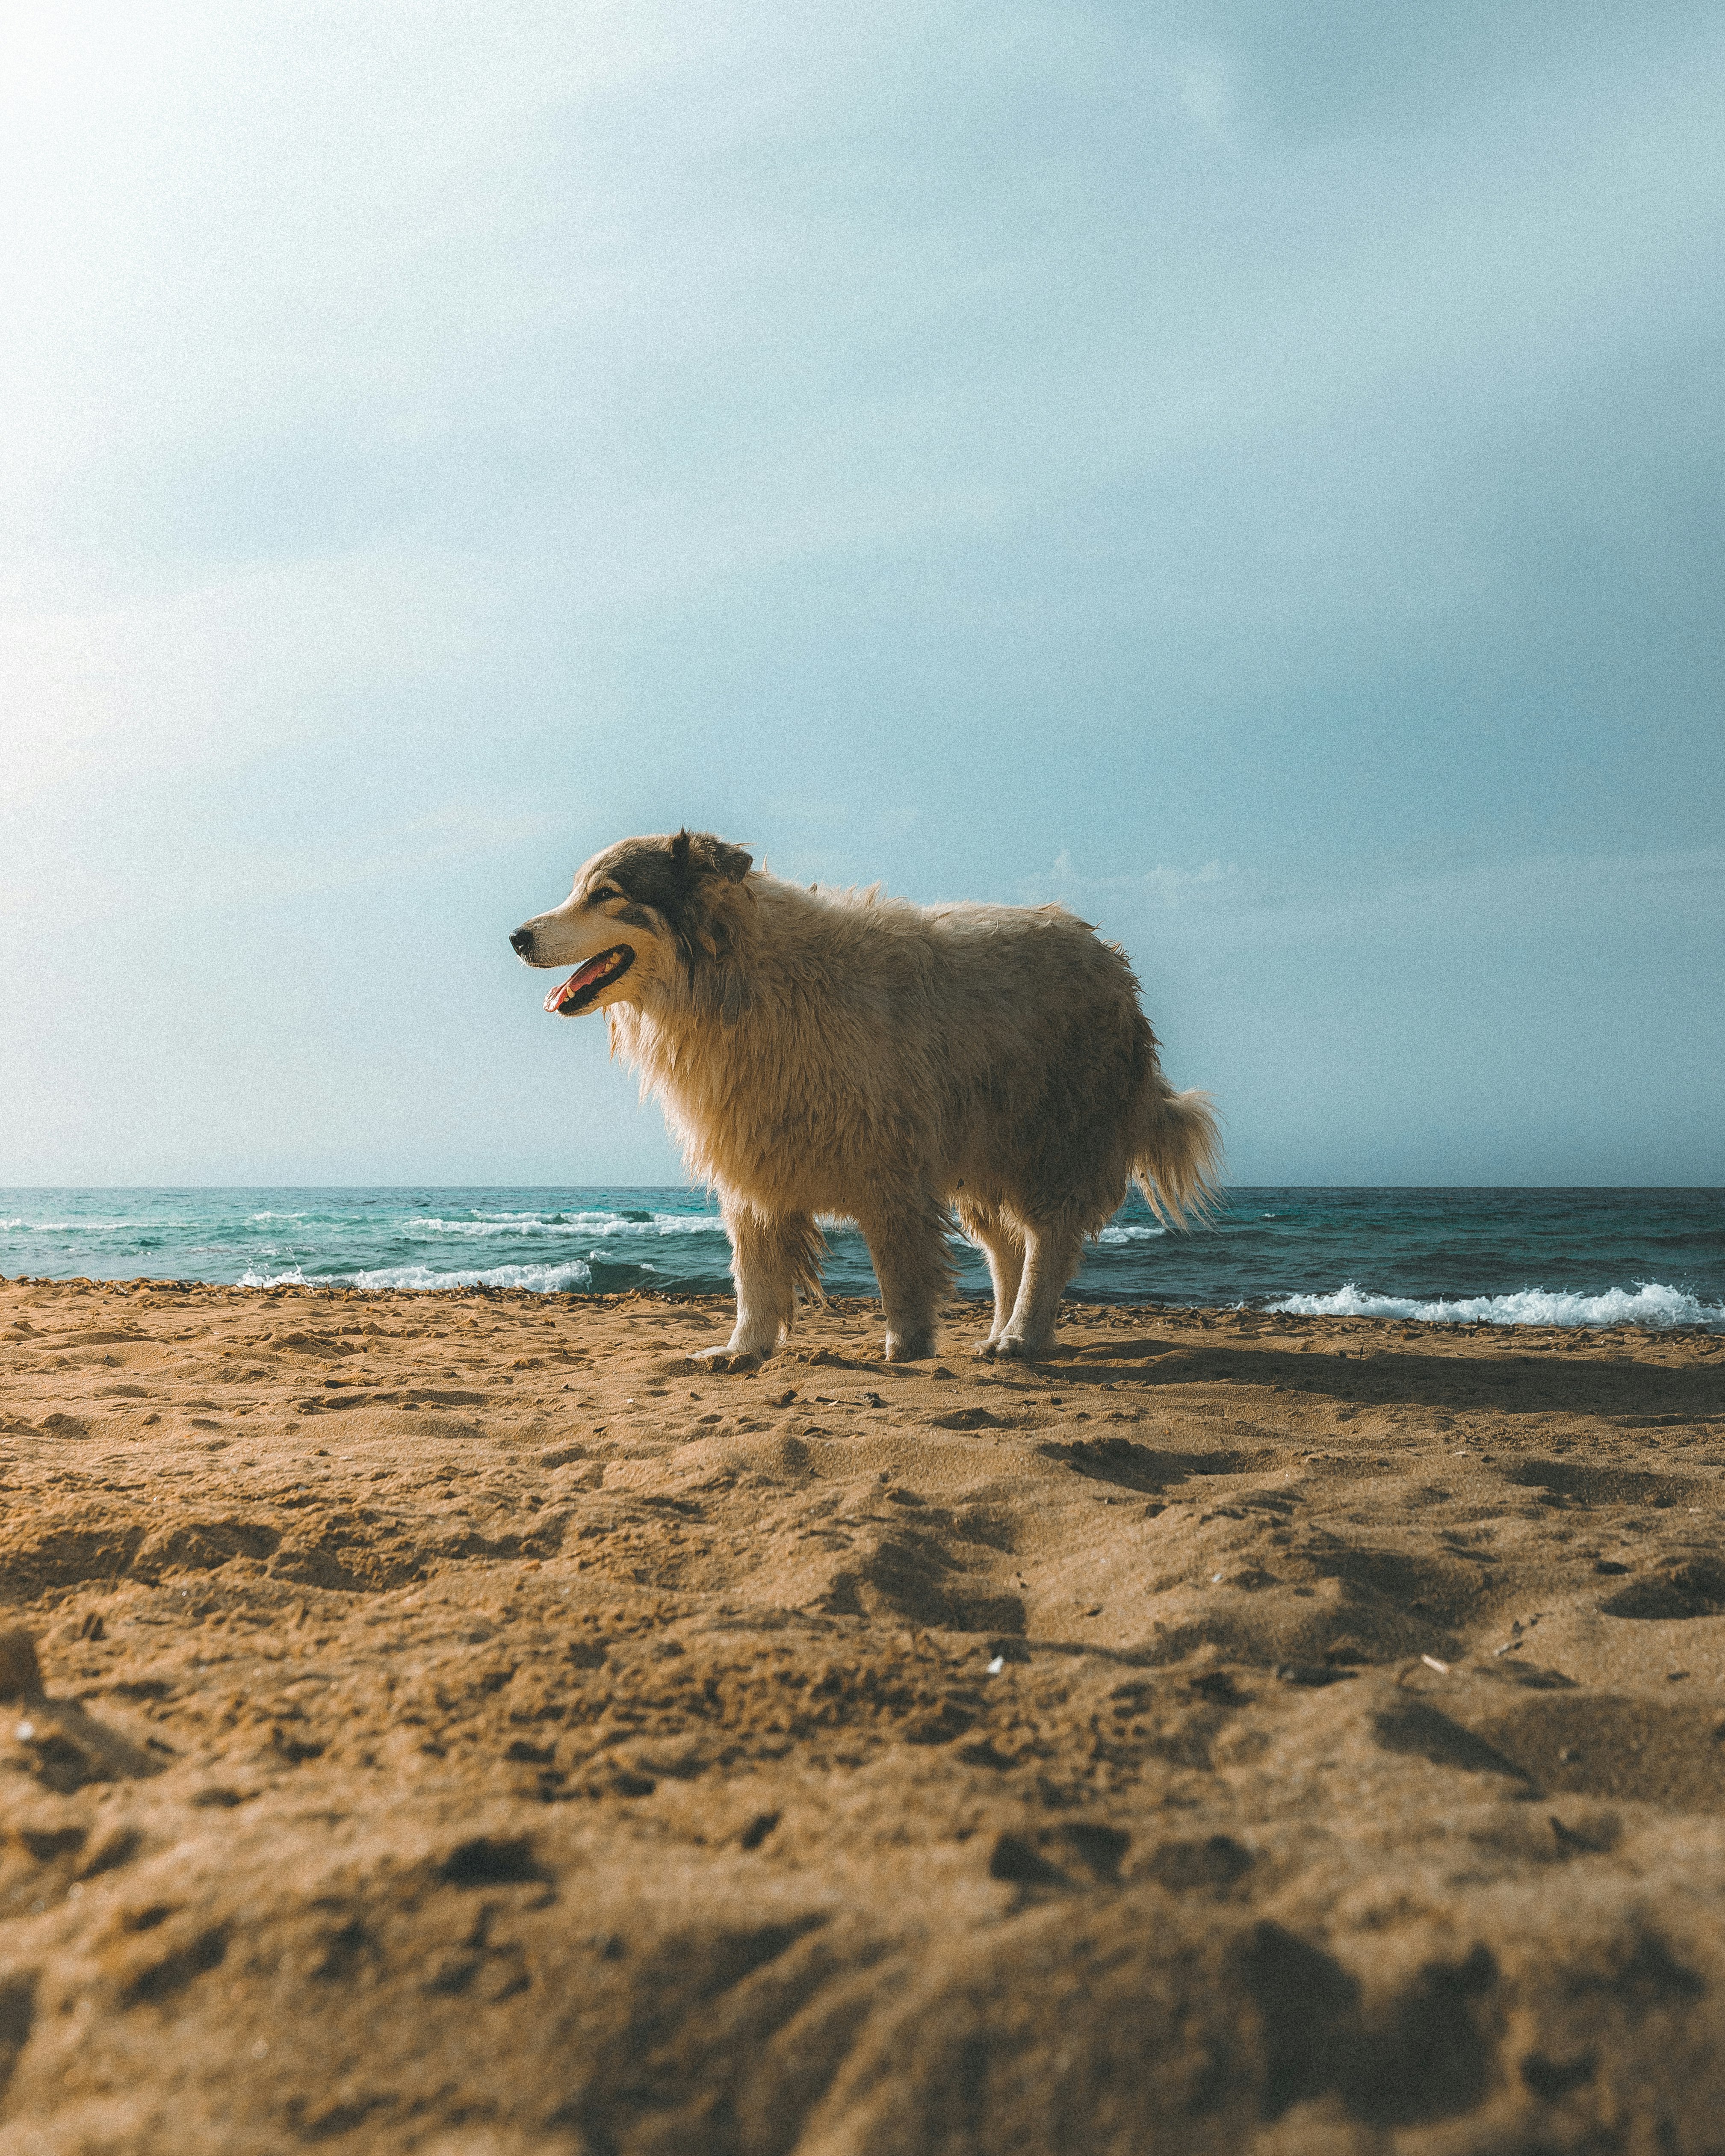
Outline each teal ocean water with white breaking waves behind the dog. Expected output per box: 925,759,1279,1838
0,1184,1725,1330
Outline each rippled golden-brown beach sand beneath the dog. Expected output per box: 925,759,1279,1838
0,1283,1725,2156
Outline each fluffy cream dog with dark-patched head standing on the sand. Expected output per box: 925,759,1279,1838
509,830,1220,1367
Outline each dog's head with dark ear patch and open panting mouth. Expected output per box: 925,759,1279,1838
509,830,755,1018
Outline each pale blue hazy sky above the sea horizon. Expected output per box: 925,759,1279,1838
0,0,1725,1184
